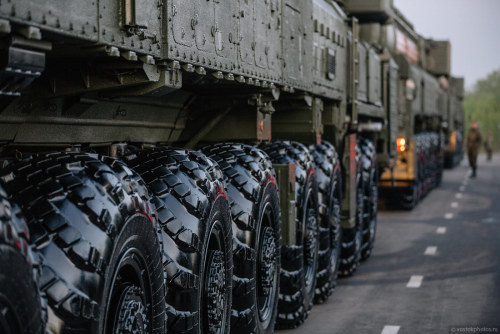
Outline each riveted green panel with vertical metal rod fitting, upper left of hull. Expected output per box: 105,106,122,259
99,0,163,57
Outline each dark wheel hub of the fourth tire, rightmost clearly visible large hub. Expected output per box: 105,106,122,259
259,227,276,296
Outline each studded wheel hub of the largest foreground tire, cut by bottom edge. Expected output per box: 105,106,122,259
118,285,148,334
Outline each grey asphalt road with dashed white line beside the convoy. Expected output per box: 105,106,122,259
278,155,500,334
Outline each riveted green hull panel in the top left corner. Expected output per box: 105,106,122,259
0,0,98,42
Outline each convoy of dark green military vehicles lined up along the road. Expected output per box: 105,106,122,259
0,0,464,333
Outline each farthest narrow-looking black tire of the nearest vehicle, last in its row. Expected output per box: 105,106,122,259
361,139,378,261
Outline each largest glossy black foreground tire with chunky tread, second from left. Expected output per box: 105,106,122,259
0,153,165,334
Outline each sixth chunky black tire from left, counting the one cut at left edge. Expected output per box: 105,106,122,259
310,140,342,303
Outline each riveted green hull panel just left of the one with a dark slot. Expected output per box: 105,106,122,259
282,0,313,91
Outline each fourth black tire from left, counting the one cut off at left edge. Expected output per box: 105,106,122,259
202,143,281,333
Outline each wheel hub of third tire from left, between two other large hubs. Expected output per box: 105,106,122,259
206,250,226,334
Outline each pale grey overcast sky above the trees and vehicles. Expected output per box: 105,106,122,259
394,0,500,89
